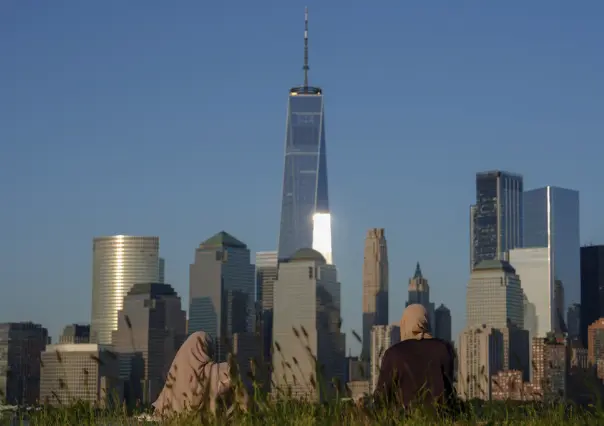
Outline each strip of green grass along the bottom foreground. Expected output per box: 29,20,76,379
0,401,604,426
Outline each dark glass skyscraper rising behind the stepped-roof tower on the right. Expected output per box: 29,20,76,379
470,170,524,267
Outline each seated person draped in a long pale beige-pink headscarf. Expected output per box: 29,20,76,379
153,331,231,415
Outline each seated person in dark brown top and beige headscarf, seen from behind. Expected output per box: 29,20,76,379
375,304,454,407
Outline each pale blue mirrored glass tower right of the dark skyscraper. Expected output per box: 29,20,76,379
524,186,581,337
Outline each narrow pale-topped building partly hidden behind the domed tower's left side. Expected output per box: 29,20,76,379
256,251,279,365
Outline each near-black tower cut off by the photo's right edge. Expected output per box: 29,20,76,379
581,245,604,347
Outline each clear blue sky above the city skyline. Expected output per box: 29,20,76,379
0,0,604,349
